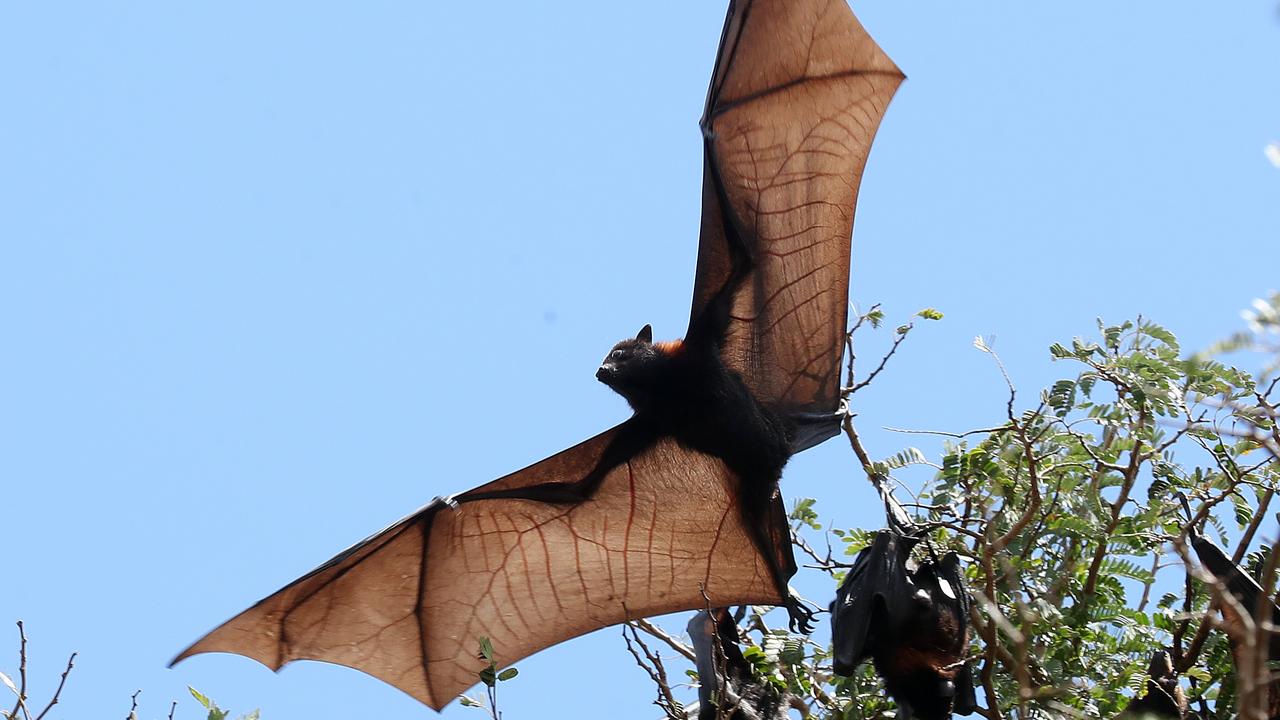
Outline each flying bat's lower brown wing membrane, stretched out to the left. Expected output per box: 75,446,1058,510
174,428,783,710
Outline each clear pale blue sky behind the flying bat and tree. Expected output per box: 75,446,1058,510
0,0,1280,720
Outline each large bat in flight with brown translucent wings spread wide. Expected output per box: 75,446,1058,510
174,0,902,710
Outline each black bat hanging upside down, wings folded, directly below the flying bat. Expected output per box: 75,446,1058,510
831,483,978,720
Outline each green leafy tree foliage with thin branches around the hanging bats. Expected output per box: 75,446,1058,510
624,295,1280,720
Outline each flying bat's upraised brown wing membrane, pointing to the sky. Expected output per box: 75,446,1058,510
691,0,902,413
